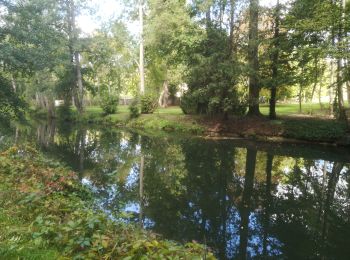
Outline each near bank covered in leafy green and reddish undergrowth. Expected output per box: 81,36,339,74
0,147,214,260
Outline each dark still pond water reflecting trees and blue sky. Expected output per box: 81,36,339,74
0,123,350,259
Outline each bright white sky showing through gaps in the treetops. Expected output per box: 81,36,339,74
78,0,287,35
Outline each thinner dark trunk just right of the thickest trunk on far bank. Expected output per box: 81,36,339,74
269,0,280,119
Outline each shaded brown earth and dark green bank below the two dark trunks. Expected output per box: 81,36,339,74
197,116,350,146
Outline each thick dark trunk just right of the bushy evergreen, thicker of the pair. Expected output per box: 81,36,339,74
248,0,261,116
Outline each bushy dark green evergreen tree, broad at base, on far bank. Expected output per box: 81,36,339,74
181,26,246,115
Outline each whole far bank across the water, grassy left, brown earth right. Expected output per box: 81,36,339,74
31,107,350,145
